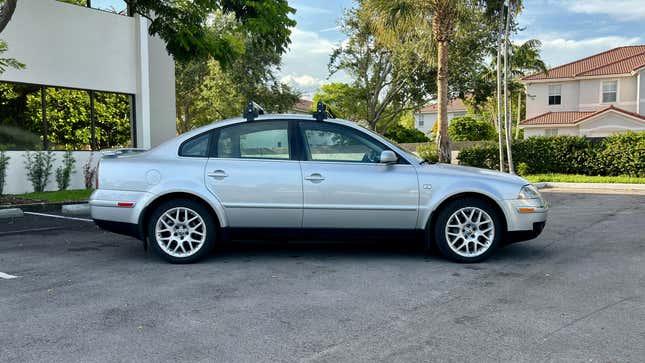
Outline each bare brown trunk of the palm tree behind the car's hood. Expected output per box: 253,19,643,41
436,41,450,163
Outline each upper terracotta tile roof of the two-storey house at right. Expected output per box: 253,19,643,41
522,45,645,81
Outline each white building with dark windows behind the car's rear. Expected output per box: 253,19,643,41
0,0,176,193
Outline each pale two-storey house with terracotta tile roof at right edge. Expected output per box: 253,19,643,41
520,45,645,137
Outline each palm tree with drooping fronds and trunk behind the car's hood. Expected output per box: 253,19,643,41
364,0,474,163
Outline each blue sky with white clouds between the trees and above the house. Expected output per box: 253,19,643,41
97,0,645,98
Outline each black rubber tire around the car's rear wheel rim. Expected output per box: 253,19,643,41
147,198,217,264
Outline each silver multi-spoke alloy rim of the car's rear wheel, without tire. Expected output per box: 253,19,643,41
155,207,206,257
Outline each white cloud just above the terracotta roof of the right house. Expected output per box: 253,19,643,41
518,34,642,67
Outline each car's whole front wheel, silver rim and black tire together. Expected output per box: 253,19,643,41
434,198,503,263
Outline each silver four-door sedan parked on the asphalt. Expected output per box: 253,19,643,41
90,104,548,263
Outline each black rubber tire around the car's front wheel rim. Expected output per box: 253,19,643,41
432,197,504,263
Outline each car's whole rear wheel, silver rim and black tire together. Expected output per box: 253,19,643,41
148,199,217,263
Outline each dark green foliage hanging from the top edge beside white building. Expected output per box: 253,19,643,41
124,0,296,68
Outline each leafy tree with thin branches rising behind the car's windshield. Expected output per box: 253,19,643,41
328,7,431,133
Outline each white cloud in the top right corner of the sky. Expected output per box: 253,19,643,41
563,0,645,21
